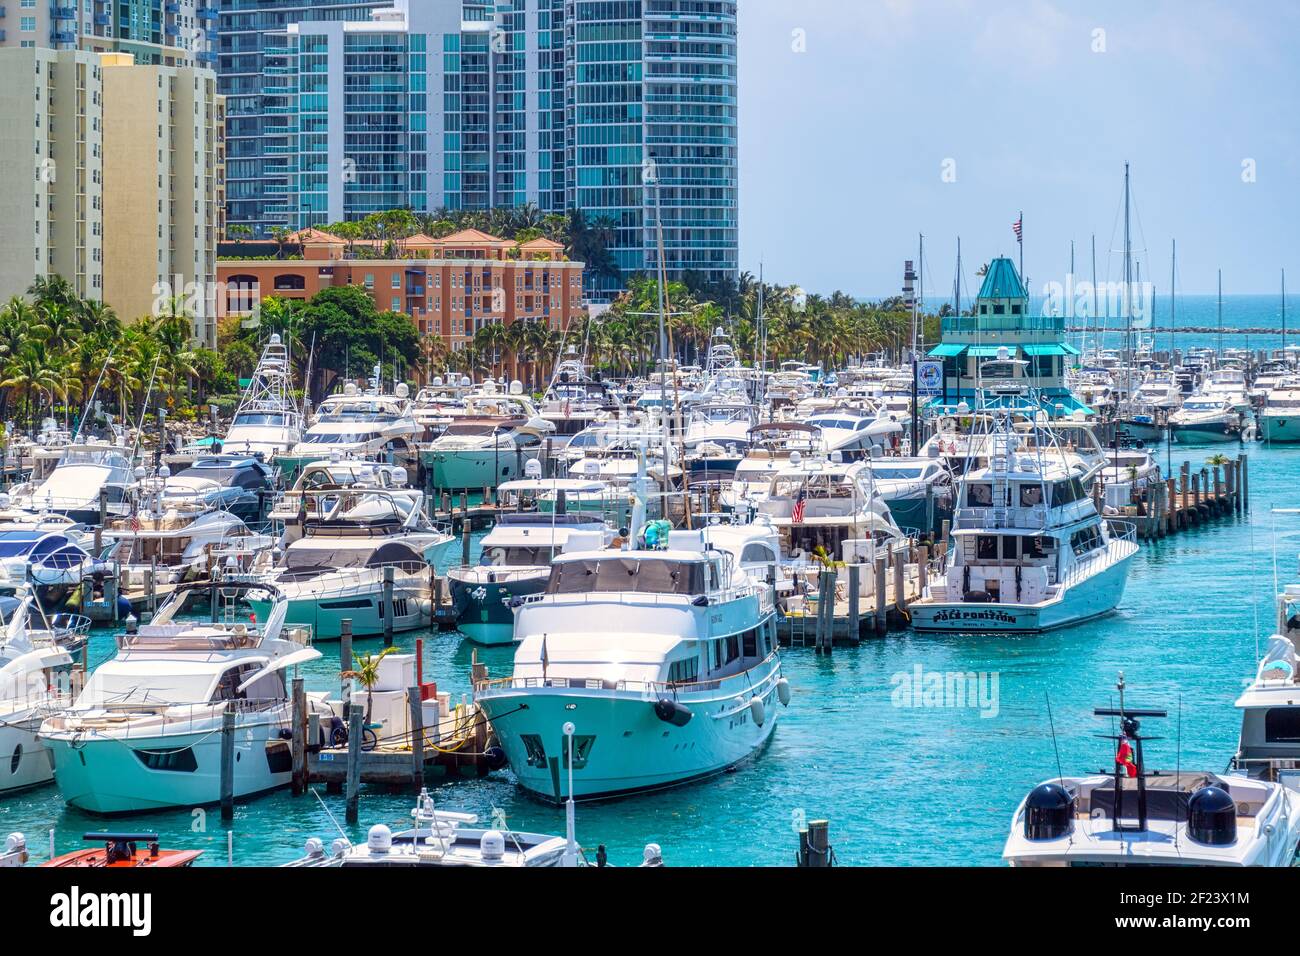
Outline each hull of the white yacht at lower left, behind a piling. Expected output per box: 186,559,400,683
44,713,291,814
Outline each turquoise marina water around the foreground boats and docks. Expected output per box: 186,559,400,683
0,446,1300,865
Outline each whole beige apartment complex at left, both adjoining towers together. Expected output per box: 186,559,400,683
0,47,225,345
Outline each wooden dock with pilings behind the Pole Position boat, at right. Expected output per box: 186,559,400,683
1092,455,1251,541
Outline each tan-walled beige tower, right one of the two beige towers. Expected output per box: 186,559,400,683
103,53,222,346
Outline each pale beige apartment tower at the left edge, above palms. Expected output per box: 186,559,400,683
0,47,104,300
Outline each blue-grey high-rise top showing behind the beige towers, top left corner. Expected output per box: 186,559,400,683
0,0,217,66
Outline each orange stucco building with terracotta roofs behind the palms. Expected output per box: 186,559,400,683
217,229,586,349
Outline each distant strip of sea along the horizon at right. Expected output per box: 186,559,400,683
926,290,1300,351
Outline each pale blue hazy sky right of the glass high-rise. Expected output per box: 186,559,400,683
740,0,1300,298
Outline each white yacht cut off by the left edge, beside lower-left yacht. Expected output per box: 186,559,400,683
0,594,77,793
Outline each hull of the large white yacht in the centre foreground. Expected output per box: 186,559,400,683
478,656,781,803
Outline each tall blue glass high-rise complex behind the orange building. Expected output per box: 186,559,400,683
220,0,738,295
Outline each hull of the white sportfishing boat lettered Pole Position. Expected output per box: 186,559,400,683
909,550,1136,633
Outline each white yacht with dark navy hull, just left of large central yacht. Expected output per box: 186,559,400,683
447,494,614,645
